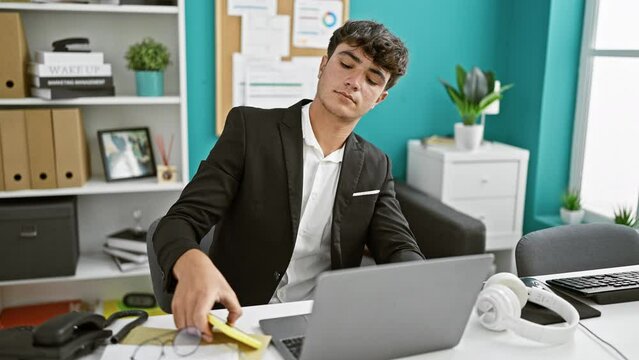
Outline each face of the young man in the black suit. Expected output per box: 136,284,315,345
316,43,390,122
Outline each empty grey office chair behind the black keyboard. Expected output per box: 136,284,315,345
515,224,639,276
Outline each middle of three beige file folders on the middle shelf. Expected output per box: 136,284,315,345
24,109,57,189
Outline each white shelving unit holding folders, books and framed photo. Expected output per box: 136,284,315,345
0,0,189,309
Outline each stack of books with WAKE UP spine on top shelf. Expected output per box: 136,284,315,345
29,50,115,100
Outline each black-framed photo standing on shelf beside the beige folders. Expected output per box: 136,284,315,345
98,127,155,181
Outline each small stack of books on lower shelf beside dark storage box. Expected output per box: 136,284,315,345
104,229,149,272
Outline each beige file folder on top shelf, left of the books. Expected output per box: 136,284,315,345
0,12,29,98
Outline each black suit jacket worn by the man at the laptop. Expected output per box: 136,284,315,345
153,100,423,306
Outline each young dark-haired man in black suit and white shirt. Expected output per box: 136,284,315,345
153,21,423,340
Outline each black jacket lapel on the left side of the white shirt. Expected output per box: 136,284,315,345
279,100,310,243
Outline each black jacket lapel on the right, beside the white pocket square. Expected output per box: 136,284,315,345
331,133,365,269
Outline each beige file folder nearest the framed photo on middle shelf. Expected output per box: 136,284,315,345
51,109,91,187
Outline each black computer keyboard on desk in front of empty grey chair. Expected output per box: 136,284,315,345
546,271,639,304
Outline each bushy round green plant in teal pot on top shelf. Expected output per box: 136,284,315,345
125,37,170,96
